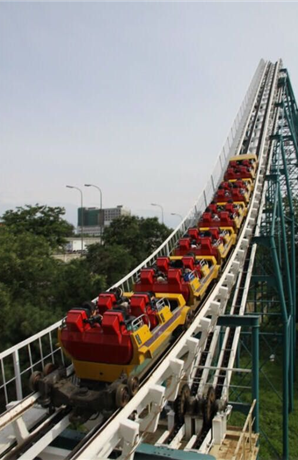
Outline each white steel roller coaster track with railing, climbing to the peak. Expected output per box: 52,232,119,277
0,60,282,459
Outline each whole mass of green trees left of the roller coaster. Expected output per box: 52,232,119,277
0,205,170,350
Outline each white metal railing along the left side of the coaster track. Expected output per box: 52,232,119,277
0,60,266,414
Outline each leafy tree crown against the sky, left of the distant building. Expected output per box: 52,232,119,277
2,204,74,248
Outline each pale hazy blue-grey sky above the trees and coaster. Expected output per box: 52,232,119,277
0,2,298,227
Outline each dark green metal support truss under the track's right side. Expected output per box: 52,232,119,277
252,69,298,460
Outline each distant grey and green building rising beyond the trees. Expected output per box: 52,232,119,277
77,205,131,235
